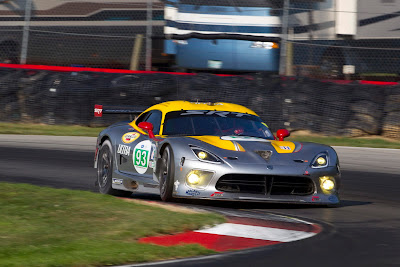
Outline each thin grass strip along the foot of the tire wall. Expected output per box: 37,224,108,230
0,122,400,149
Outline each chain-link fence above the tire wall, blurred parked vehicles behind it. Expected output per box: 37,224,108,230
0,0,400,77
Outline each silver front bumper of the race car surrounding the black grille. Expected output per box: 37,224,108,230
173,158,341,205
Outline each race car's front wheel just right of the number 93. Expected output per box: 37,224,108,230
158,146,175,201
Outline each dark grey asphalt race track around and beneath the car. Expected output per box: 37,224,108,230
0,135,400,266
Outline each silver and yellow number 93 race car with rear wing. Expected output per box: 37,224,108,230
94,101,341,206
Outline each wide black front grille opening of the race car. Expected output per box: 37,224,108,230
215,174,314,195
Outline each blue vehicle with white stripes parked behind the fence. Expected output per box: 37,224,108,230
164,0,281,72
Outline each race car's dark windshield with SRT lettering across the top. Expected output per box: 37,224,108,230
163,110,274,140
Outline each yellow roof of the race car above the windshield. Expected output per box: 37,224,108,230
145,100,258,116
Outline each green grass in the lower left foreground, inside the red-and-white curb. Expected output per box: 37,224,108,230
0,182,224,267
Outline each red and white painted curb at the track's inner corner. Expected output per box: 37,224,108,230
139,217,322,251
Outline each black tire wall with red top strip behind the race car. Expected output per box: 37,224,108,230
0,64,400,139
